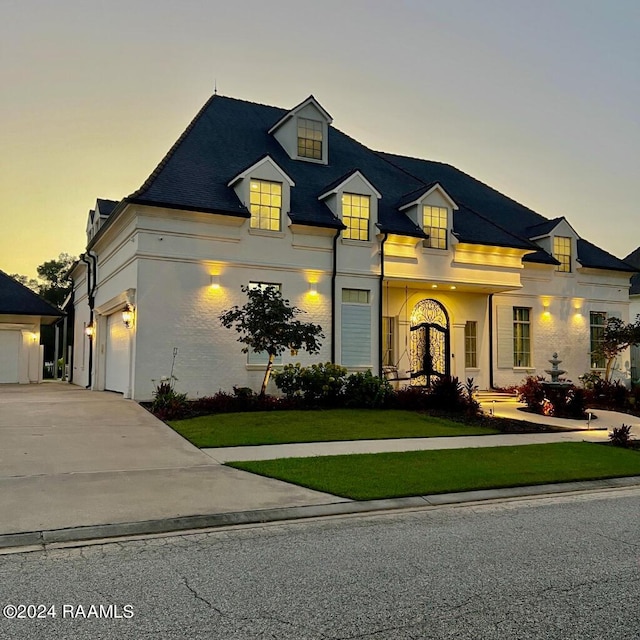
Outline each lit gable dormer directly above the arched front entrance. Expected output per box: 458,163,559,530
398,182,458,249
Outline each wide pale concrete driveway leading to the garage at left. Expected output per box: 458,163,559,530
0,383,340,534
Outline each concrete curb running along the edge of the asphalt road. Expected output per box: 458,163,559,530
0,476,640,549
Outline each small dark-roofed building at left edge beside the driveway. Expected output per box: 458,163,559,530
0,271,63,384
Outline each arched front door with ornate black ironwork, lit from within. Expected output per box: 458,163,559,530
411,300,450,387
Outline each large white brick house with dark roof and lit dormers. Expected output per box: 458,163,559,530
72,95,633,400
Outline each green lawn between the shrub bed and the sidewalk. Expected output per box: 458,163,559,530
169,409,499,447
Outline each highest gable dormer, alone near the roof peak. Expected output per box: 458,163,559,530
269,96,333,164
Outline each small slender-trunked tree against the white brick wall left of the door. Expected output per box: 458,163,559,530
220,286,324,395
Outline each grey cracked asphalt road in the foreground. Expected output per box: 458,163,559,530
0,488,640,640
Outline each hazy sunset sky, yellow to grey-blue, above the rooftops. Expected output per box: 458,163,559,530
0,0,640,276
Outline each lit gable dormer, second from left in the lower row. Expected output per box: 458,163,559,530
318,169,382,242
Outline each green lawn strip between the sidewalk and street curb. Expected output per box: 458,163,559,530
228,442,640,500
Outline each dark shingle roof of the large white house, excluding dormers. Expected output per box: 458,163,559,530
115,95,627,270
